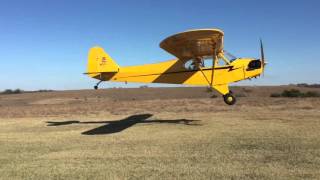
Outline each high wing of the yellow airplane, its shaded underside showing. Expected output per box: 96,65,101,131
160,29,224,60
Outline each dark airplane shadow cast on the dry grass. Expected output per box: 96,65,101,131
46,114,201,135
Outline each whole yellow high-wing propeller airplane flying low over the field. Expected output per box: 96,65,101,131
85,29,266,105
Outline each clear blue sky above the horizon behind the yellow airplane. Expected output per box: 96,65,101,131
0,0,320,90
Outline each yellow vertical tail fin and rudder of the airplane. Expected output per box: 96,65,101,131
86,47,119,76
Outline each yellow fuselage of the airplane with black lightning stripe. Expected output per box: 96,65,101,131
94,58,262,86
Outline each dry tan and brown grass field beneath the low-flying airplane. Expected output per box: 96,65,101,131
0,87,320,179
